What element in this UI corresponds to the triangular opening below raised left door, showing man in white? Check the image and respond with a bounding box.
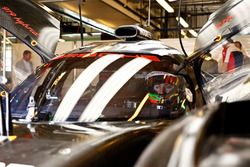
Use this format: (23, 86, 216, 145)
(0, 28, 42, 90)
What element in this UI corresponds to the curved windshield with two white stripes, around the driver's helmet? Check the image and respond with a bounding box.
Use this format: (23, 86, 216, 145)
(11, 54, 187, 122)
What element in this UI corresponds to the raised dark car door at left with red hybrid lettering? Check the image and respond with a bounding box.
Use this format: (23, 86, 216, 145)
(0, 0, 60, 61)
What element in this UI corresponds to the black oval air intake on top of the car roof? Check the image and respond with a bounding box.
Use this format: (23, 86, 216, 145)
(115, 25, 152, 40)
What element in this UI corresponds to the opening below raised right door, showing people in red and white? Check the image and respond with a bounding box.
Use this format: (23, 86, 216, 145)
(201, 35, 250, 83)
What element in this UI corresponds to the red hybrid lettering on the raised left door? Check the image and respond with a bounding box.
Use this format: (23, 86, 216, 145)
(2, 6, 39, 36)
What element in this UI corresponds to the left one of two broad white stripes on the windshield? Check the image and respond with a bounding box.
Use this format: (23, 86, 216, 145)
(53, 54, 123, 122)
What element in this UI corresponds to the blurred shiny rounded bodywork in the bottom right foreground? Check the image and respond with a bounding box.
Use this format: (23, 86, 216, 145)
(135, 101, 249, 167)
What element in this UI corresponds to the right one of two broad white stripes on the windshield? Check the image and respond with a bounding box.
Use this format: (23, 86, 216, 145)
(78, 57, 151, 122)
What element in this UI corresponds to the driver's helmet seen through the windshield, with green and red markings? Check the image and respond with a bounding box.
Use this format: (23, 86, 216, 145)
(145, 71, 186, 114)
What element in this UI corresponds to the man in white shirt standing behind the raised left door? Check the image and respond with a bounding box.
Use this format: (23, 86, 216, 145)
(15, 50, 33, 82)
